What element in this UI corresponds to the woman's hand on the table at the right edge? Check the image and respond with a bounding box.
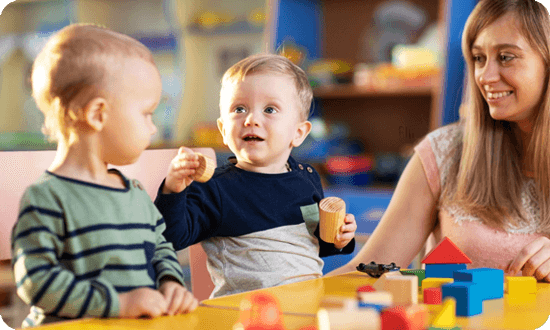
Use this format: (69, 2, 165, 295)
(506, 237, 550, 282)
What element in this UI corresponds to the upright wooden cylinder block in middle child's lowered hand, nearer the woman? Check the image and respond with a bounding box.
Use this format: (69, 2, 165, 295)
(319, 197, 346, 243)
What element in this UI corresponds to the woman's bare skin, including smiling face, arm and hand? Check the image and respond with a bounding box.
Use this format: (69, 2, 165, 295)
(328, 14, 550, 282)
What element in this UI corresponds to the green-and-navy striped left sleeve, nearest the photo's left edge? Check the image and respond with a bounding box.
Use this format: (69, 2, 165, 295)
(12, 187, 119, 318)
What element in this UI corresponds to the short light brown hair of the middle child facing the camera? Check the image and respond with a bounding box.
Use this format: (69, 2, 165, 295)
(220, 54, 313, 120)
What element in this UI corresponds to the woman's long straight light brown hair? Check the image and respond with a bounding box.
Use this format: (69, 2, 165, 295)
(442, 0, 550, 233)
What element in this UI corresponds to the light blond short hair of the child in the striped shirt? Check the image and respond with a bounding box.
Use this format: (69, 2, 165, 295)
(31, 24, 154, 141)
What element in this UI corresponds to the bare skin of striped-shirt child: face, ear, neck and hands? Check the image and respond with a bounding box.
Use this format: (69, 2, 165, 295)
(48, 59, 198, 318)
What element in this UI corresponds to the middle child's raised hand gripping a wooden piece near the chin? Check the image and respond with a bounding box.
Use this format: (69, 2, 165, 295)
(162, 147, 199, 194)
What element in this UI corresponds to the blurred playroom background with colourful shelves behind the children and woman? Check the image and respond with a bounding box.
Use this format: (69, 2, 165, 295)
(0, 0, 476, 324)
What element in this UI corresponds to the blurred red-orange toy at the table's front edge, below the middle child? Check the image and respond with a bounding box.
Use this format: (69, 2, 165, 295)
(233, 292, 286, 330)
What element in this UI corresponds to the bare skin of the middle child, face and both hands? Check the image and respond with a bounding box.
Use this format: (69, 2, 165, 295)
(162, 73, 357, 249)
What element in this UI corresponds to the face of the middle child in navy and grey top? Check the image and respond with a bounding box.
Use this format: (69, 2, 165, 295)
(218, 73, 309, 173)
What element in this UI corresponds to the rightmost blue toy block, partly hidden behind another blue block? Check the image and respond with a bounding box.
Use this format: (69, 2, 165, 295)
(453, 268, 504, 300)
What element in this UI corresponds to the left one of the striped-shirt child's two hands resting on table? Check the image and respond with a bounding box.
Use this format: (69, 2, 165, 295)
(118, 288, 168, 318)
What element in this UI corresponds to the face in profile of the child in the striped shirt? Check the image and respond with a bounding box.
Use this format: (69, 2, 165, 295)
(102, 58, 162, 165)
